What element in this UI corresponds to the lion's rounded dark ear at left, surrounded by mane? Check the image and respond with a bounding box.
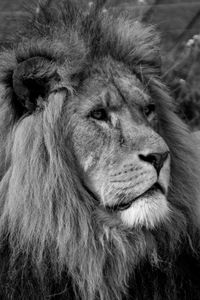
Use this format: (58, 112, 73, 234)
(13, 56, 61, 112)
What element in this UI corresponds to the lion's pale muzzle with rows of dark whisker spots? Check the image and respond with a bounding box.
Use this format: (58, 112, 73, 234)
(101, 147, 170, 206)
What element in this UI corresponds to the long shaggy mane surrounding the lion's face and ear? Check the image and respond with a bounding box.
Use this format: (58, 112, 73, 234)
(0, 1, 200, 300)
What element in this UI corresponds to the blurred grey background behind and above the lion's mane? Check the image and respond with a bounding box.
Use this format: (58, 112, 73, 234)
(0, 0, 200, 130)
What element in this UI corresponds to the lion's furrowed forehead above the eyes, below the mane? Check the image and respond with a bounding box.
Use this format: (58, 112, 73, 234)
(76, 62, 150, 110)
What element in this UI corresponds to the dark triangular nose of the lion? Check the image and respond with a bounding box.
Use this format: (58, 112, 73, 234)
(139, 151, 169, 176)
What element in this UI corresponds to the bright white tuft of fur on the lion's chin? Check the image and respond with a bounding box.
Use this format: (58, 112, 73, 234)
(120, 192, 170, 229)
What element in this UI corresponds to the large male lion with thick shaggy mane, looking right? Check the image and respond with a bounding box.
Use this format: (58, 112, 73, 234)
(0, 0, 200, 300)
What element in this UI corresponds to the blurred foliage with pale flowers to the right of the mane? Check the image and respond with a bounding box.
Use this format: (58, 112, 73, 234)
(163, 34, 200, 129)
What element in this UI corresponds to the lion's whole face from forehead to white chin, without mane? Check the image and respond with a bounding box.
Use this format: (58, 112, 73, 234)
(71, 62, 170, 228)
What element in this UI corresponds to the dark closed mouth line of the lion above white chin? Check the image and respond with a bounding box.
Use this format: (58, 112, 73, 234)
(106, 182, 165, 211)
